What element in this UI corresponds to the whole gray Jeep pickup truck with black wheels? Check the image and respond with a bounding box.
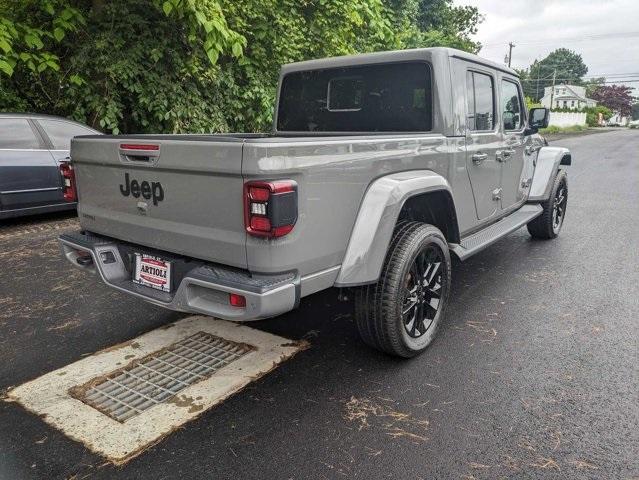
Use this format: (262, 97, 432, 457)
(60, 48, 571, 357)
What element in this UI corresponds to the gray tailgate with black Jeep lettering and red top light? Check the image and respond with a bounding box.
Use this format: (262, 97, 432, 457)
(71, 135, 246, 268)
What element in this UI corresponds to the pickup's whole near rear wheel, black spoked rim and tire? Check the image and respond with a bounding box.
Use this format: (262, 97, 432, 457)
(355, 222, 451, 358)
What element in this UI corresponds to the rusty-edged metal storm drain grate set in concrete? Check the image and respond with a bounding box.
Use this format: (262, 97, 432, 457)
(73, 332, 253, 422)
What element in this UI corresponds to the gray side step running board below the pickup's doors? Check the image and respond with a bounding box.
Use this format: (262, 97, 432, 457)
(450, 204, 543, 260)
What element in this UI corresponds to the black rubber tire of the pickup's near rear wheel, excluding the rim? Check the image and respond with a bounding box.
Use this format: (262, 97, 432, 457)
(355, 222, 451, 358)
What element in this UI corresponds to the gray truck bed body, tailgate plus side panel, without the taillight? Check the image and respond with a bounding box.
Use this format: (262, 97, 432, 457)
(71, 133, 452, 284)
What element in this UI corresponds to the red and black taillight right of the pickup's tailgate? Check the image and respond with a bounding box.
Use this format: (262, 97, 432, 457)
(244, 180, 297, 238)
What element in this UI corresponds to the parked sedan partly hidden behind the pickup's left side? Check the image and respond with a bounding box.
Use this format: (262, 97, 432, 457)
(0, 113, 99, 219)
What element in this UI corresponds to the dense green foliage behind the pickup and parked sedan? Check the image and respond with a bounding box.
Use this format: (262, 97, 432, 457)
(0, 0, 481, 133)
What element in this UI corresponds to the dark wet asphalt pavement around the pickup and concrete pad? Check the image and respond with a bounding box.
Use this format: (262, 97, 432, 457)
(0, 130, 639, 479)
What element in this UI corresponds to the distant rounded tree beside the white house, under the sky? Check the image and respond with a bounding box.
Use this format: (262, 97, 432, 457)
(523, 48, 588, 100)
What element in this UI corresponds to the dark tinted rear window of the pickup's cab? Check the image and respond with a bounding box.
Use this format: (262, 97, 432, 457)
(277, 62, 432, 132)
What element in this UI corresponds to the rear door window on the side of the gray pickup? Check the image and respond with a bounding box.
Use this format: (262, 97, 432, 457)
(466, 71, 495, 131)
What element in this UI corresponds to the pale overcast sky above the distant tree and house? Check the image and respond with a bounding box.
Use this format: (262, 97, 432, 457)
(454, 0, 639, 88)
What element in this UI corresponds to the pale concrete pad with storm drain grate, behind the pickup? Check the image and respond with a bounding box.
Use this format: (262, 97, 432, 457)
(8, 316, 305, 464)
